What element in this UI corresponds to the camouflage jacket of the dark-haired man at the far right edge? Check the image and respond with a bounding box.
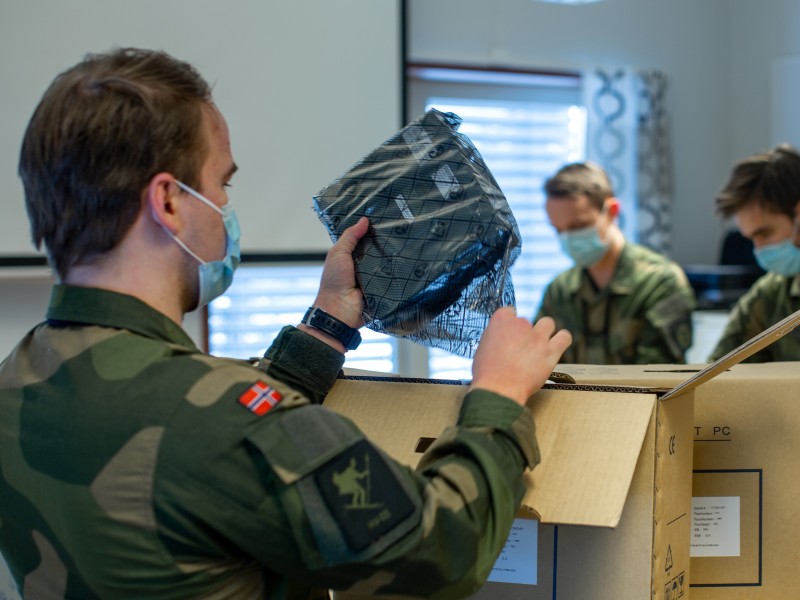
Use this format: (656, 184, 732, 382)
(709, 273, 800, 362)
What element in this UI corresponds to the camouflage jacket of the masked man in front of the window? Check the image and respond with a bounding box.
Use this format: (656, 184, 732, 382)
(536, 243, 695, 364)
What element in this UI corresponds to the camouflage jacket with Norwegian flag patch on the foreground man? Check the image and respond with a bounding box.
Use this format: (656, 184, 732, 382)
(0, 286, 538, 600)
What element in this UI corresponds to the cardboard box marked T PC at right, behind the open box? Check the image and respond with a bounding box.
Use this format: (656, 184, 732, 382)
(559, 362, 800, 600)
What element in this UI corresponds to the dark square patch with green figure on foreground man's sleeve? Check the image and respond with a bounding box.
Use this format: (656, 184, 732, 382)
(314, 440, 414, 552)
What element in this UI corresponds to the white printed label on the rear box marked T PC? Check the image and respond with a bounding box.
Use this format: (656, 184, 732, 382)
(690, 496, 741, 557)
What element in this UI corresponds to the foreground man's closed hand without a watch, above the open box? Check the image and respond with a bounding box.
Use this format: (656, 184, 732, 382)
(470, 307, 572, 404)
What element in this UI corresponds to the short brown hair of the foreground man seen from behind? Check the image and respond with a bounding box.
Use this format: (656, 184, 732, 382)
(19, 48, 211, 278)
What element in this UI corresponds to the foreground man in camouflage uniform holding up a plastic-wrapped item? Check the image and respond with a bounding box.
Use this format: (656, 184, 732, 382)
(0, 49, 570, 600)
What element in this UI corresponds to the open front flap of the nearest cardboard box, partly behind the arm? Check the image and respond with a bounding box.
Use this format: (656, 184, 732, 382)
(325, 377, 656, 527)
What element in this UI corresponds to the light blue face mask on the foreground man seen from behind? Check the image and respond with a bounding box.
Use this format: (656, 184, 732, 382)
(162, 180, 241, 308)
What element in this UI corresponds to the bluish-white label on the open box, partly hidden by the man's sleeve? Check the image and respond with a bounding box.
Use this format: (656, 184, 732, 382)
(487, 519, 539, 585)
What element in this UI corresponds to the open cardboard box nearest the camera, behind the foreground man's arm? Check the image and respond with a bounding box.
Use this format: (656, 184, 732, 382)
(325, 379, 693, 600)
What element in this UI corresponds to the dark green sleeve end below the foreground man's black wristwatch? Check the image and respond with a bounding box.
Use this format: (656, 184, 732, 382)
(258, 326, 344, 404)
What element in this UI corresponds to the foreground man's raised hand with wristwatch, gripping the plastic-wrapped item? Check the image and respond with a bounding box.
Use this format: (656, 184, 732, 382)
(314, 217, 369, 328)
